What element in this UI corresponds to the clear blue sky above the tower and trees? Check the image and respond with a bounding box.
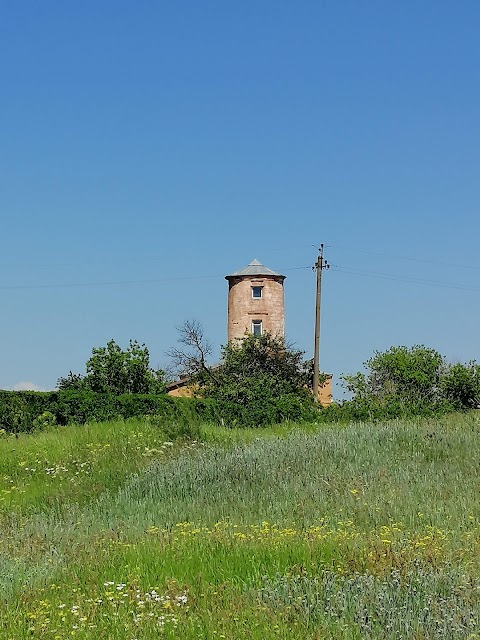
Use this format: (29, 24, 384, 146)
(0, 0, 480, 395)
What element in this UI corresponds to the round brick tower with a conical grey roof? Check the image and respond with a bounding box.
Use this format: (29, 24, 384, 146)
(225, 260, 285, 341)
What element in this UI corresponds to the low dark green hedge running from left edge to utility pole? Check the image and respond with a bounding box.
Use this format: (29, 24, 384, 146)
(0, 389, 318, 440)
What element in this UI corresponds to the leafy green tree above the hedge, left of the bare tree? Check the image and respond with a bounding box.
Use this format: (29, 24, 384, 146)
(57, 340, 165, 395)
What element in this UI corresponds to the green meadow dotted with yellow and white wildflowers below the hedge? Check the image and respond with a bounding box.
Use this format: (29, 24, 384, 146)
(0, 413, 480, 640)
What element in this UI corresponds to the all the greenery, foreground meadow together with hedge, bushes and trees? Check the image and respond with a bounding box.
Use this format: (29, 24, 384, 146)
(0, 302, 480, 640)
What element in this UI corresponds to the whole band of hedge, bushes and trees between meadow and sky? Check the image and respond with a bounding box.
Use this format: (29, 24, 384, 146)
(0, 338, 480, 433)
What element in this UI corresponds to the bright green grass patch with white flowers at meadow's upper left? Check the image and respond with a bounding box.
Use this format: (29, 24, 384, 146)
(0, 418, 197, 515)
